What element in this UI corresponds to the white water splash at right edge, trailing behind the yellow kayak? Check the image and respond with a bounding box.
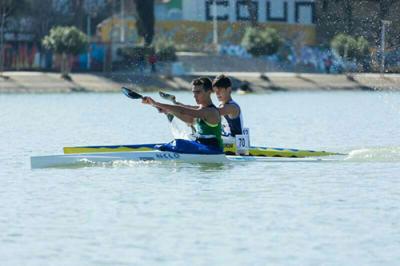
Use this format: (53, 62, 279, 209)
(345, 147, 400, 162)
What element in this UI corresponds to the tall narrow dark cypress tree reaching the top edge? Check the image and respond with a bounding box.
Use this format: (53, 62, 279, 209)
(135, 0, 155, 46)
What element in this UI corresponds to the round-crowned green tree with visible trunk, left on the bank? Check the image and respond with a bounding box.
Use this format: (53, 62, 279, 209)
(43, 27, 89, 79)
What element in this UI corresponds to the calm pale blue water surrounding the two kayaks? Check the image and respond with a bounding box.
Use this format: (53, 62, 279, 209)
(0, 92, 400, 265)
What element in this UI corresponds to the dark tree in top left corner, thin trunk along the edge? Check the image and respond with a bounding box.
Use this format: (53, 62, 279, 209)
(0, 0, 27, 74)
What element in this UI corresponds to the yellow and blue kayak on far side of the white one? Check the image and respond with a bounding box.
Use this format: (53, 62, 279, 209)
(63, 143, 342, 158)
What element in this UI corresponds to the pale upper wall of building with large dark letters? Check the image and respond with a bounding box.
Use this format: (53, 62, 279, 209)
(182, 0, 315, 25)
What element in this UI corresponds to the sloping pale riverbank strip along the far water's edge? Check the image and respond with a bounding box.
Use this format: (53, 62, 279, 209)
(0, 72, 400, 93)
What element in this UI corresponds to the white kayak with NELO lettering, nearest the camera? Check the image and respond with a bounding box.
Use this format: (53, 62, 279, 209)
(31, 150, 332, 169)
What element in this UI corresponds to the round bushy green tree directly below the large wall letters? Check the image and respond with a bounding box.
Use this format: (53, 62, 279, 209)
(242, 28, 283, 56)
